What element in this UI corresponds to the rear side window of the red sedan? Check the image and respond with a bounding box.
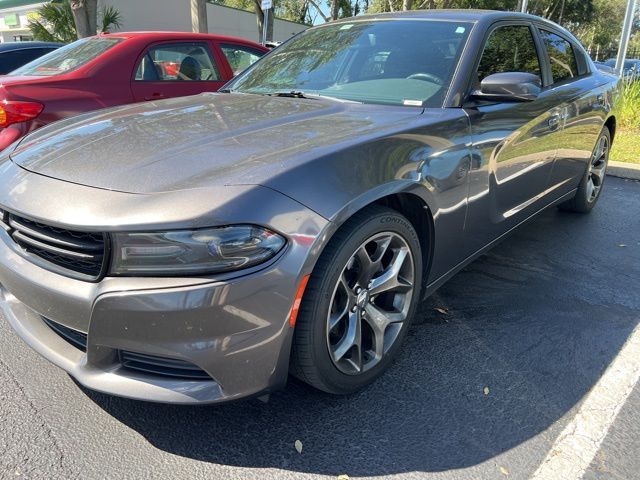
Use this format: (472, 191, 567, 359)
(135, 43, 221, 82)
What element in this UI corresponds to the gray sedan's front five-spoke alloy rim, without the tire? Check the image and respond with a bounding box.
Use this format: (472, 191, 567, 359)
(326, 232, 415, 375)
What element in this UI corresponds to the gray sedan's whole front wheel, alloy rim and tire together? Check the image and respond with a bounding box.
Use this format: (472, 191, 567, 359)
(291, 206, 422, 394)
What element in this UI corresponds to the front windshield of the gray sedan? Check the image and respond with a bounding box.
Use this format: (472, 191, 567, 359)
(227, 20, 472, 107)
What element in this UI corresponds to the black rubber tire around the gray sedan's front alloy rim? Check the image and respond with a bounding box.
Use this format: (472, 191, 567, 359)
(291, 205, 422, 394)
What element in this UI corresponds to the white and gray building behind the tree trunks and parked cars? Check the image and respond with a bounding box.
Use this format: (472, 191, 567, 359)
(0, 0, 308, 42)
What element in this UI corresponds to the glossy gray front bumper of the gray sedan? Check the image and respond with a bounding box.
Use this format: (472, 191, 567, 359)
(0, 169, 329, 404)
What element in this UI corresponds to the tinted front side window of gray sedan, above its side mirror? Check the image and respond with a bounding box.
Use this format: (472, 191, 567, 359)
(478, 25, 541, 82)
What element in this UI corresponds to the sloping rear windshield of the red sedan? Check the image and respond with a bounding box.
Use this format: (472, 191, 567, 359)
(9, 37, 123, 76)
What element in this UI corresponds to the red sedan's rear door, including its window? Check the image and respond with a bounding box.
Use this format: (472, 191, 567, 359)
(131, 41, 225, 102)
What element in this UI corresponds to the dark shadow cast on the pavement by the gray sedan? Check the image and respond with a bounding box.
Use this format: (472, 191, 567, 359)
(87, 183, 640, 476)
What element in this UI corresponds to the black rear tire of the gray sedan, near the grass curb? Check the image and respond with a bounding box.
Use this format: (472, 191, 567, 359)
(558, 127, 611, 213)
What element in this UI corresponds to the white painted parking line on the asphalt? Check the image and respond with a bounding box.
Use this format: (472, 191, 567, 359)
(531, 325, 640, 480)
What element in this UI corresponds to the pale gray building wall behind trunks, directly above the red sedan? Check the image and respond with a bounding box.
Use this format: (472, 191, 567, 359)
(99, 0, 308, 42)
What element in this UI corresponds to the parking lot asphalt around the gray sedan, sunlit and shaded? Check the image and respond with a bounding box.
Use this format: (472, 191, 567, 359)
(0, 178, 640, 479)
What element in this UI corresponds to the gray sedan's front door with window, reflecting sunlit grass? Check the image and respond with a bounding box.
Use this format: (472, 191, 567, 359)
(465, 22, 562, 251)
